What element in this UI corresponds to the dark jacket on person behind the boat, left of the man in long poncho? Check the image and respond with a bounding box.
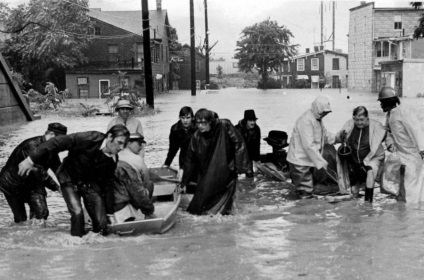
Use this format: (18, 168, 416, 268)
(165, 121, 196, 168)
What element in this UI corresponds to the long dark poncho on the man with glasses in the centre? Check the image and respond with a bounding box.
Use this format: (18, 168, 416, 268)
(182, 119, 252, 214)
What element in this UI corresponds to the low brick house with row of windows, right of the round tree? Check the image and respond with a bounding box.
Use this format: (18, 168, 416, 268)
(279, 48, 348, 88)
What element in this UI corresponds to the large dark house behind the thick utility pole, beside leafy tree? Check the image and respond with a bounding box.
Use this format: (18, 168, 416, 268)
(66, 1, 170, 98)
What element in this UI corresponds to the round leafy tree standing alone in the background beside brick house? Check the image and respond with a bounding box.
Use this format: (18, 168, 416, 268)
(235, 19, 298, 87)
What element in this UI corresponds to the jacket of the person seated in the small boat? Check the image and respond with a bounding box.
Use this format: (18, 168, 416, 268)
(114, 161, 155, 215)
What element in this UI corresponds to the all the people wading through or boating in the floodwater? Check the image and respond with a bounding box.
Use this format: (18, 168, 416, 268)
(0, 87, 424, 237)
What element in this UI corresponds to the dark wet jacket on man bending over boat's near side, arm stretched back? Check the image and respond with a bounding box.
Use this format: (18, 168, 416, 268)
(30, 131, 118, 214)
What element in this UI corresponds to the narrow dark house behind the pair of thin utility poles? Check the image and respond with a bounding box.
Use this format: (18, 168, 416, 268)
(172, 44, 206, 90)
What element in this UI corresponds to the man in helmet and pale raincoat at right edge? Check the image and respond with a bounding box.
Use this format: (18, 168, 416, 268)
(378, 86, 424, 203)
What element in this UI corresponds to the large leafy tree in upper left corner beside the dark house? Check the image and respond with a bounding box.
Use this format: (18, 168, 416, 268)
(0, 0, 93, 90)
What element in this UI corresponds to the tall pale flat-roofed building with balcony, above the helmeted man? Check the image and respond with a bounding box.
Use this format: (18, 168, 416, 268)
(349, 2, 424, 96)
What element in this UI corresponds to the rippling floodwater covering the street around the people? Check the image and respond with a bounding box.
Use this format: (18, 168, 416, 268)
(0, 89, 424, 279)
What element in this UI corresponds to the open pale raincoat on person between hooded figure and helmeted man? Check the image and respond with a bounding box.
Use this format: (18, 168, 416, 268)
(336, 120, 386, 190)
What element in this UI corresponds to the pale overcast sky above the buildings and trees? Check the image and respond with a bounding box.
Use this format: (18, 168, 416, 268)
(5, 0, 418, 59)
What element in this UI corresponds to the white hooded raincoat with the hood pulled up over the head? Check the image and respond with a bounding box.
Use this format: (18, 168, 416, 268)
(287, 96, 335, 170)
